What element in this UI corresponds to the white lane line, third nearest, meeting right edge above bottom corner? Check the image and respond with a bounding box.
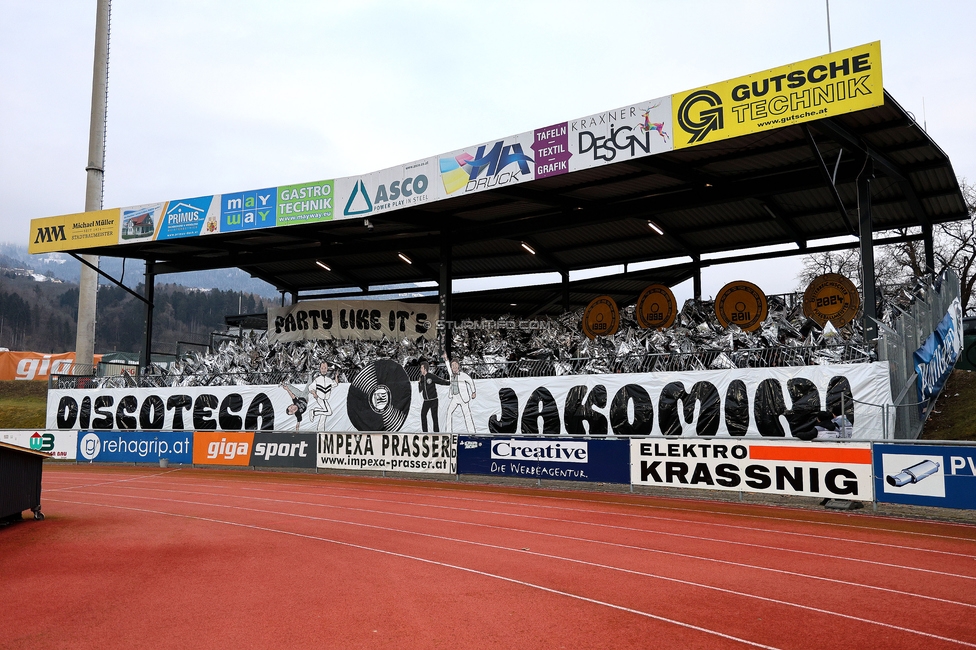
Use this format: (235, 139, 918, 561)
(74, 486, 976, 609)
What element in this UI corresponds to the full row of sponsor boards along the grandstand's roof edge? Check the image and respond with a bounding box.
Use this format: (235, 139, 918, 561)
(28, 42, 884, 254)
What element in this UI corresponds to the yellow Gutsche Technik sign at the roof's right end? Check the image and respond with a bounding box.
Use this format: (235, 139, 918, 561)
(671, 41, 884, 149)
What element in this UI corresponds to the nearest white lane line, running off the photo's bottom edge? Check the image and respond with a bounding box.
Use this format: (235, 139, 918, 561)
(43, 499, 784, 650)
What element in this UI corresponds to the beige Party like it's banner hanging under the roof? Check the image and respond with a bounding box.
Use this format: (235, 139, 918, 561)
(268, 300, 440, 345)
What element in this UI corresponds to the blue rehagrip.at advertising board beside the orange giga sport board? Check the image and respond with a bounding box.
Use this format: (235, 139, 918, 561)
(78, 431, 193, 464)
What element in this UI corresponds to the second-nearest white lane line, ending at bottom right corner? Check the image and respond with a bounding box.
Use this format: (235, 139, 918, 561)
(49, 493, 976, 648)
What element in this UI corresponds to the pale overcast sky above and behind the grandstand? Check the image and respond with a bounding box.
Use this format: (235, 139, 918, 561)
(0, 0, 976, 298)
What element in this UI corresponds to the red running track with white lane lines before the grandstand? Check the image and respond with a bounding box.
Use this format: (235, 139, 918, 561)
(0, 465, 976, 650)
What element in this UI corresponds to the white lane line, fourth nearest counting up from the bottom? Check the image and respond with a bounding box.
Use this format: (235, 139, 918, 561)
(89, 478, 976, 580)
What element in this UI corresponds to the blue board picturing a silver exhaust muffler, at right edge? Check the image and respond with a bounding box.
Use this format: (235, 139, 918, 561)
(874, 444, 976, 510)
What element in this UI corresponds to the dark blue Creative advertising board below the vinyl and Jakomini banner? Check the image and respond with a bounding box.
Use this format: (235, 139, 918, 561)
(458, 436, 630, 484)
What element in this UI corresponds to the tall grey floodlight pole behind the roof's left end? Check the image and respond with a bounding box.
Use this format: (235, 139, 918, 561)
(75, 0, 112, 374)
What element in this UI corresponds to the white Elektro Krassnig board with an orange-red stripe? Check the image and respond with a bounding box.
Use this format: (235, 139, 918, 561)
(630, 438, 872, 501)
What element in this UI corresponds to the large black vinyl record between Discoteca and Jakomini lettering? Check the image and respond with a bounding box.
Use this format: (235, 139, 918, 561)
(346, 359, 411, 431)
